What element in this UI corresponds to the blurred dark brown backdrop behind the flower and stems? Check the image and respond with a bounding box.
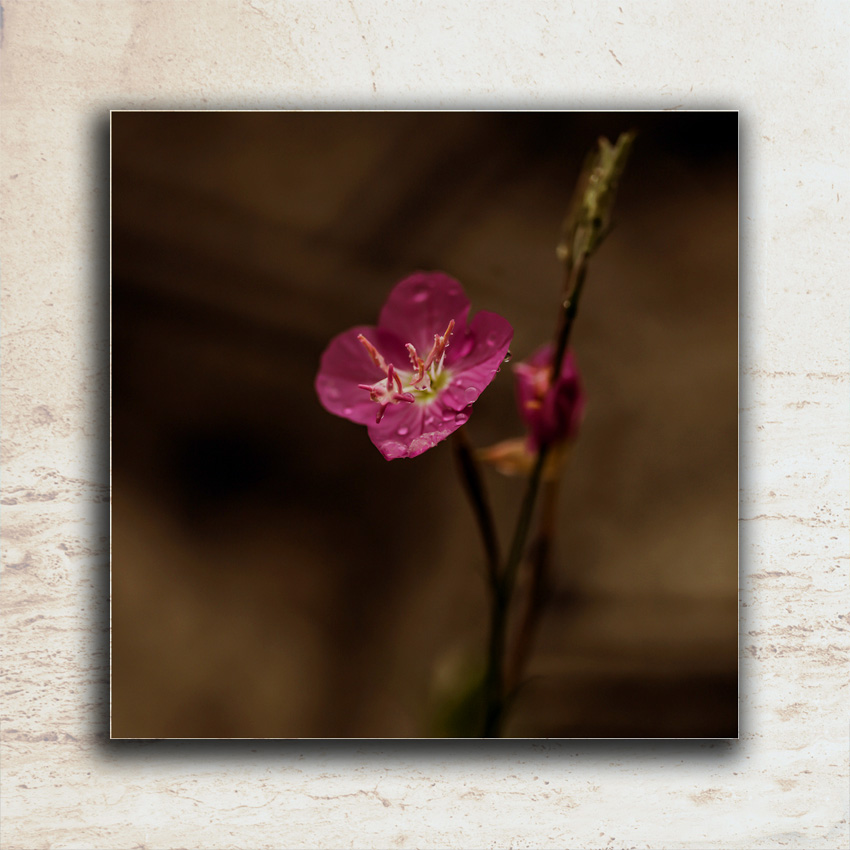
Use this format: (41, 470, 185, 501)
(112, 112, 738, 738)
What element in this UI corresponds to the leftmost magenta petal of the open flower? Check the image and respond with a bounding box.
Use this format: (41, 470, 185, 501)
(315, 325, 408, 425)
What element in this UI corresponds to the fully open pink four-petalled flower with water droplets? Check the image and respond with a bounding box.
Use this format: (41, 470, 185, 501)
(316, 272, 506, 460)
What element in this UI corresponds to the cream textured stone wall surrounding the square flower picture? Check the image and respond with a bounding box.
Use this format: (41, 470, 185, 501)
(0, 0, 850, 850)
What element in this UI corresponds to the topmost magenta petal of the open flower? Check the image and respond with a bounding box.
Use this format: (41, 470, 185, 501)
(378, 272, 469, 357)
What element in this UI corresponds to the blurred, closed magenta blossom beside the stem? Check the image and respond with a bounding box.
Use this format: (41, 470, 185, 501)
(514, 344, 585, 451)
